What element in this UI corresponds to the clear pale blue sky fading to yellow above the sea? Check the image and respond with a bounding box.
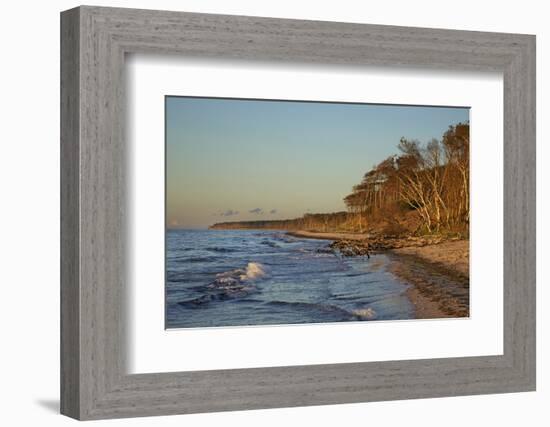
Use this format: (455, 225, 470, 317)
(165, 96, 469, 228)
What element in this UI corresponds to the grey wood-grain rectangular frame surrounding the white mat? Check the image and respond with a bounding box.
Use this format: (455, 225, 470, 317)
(61, 6, 535, 419)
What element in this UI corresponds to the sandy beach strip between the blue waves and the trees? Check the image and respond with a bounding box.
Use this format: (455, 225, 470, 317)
(288, 230, 469, 319)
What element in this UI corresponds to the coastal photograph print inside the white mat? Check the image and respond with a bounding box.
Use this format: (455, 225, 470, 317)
(165, 96, 470, 328)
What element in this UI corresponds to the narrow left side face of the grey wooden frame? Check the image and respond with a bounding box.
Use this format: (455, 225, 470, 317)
(60, 10, 80, 417)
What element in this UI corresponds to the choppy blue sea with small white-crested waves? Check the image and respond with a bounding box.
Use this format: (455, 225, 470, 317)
(165, 230, 414, 328)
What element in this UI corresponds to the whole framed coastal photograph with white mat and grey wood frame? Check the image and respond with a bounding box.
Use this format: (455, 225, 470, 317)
(61, 6, 536, 420)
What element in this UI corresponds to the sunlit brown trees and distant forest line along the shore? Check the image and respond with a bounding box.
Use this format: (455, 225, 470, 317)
(209, 123, 470, 245)
